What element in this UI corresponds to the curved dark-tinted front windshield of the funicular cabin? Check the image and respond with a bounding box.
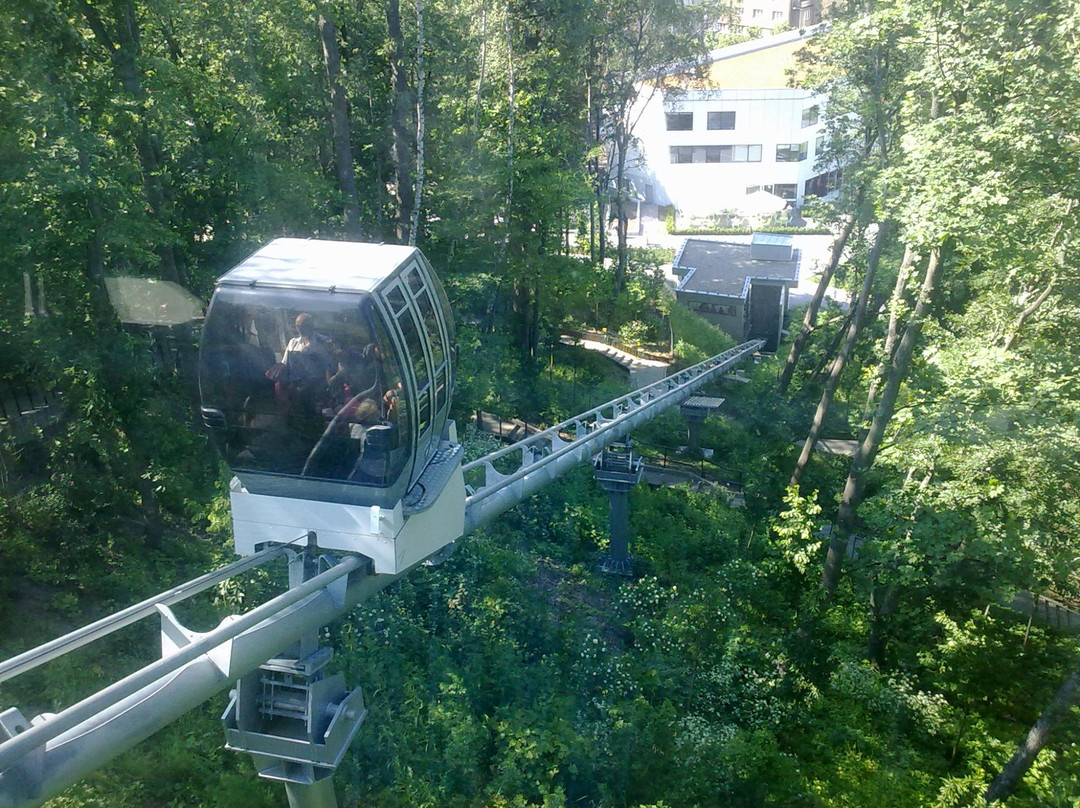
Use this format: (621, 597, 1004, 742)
(200, 287, 413, 487)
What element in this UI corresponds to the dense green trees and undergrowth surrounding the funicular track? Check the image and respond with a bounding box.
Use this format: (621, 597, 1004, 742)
(0, 0, 1080, 808)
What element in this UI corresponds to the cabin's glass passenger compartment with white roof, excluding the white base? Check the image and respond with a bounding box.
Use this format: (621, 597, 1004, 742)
(199, 239, 454, 508)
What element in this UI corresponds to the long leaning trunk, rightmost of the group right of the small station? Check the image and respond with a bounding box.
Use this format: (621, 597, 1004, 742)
(821, 245, 942, 592)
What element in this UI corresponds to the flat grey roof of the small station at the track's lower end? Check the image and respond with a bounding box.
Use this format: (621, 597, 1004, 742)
(674, 239, 801, 298)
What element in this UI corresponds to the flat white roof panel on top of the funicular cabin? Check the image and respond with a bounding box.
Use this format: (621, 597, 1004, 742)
(218, 239, 417, 292)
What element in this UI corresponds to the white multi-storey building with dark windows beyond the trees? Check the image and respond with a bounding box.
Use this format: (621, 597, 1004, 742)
(632, 29, 837, 216)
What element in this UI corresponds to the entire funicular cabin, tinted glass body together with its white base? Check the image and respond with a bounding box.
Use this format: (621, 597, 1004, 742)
(200, 239, 464, 573)
